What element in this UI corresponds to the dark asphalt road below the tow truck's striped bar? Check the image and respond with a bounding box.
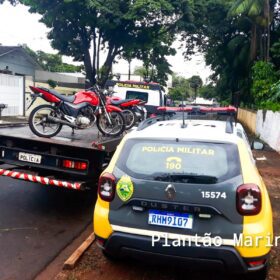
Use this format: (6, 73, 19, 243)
(0, 177, 96, 280)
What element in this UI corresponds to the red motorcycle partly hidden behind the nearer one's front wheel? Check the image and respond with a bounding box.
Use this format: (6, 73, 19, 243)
(107, 96, 147, 129)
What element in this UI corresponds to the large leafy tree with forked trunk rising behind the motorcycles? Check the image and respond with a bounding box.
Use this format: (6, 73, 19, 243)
(20, 0, 188, 85)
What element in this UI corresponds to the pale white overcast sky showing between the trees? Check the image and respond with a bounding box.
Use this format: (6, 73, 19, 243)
(0, 2, 211, 82)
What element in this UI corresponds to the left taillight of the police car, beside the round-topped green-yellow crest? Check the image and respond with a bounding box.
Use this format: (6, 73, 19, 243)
(98, 173, 116, 202)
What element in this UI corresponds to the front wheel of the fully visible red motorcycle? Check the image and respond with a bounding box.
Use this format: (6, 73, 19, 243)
(96, 112, 125, 136)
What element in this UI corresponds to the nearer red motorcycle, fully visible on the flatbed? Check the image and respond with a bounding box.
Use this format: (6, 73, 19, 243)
(29, 86, 125, 137)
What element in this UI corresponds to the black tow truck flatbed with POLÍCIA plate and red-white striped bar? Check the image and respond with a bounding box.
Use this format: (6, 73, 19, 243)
(0, 126, 122, 190)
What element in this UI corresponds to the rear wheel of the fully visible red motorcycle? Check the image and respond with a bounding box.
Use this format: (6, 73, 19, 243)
(28, 105, 62, 138)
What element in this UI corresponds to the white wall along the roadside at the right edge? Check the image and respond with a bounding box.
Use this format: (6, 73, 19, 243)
(256, 110, 280, 152)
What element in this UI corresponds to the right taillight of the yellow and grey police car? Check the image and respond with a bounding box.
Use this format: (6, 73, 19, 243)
(236, 184, 262, 216)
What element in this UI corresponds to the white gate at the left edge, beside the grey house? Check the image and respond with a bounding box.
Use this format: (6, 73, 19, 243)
(0, 74, 25, 116)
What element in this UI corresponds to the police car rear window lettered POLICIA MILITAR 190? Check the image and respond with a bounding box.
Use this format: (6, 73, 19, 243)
(117, 140, 240, 182)
